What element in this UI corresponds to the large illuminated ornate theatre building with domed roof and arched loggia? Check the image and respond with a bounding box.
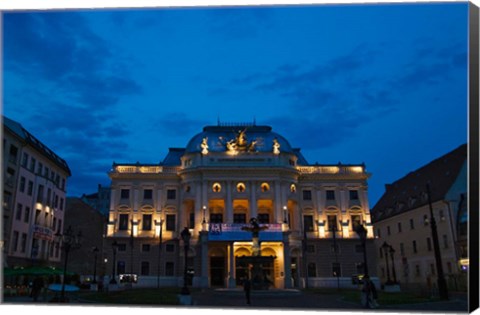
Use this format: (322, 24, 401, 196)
(106, 124, 375, 288)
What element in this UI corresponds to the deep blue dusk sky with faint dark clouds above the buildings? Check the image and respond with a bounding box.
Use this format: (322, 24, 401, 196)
(3, 2, 468, 207)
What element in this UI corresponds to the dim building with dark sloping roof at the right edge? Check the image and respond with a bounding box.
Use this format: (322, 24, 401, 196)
(372, 144, 469, 291)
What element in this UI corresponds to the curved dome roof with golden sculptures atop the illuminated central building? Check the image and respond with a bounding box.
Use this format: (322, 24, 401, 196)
(185, 125, 293, 153)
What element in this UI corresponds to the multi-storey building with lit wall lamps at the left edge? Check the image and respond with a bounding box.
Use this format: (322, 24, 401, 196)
(2, 117, 71, 267)
